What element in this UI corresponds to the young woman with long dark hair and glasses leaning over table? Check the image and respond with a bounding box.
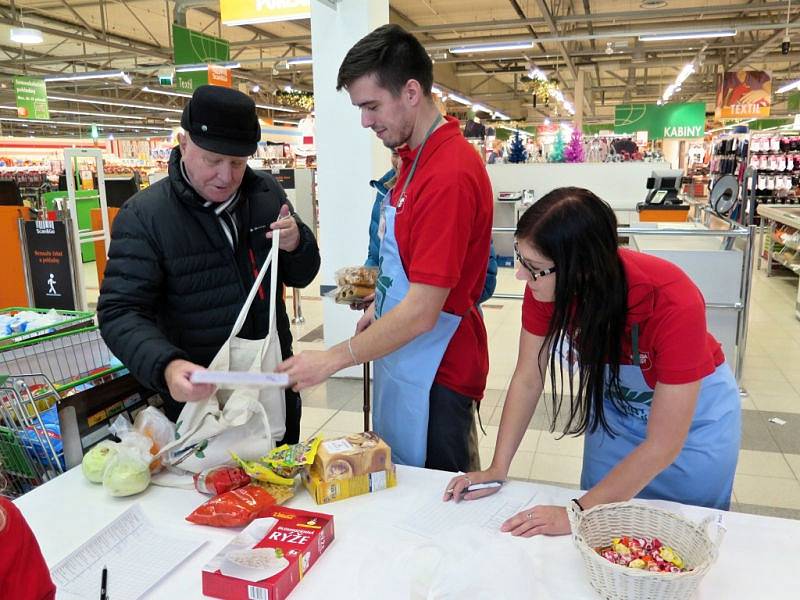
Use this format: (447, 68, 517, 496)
(444, 188, 741, 536)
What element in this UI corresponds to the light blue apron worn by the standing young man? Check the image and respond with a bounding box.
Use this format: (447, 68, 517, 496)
(372, 116, 461, 467)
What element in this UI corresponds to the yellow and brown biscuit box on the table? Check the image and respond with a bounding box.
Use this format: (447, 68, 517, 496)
(303, 431, 397, 504)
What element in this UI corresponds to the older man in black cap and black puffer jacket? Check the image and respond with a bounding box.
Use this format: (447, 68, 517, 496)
(97, 86, 320, 443)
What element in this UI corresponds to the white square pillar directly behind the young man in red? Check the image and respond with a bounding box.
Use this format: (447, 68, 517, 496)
(311, 0, 391, 377)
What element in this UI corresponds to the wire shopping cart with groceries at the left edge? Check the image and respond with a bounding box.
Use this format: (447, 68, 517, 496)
(0, 327, 127, 497)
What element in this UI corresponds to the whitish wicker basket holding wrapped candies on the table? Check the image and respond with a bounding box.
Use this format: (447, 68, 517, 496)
(567, 502, 725, 600)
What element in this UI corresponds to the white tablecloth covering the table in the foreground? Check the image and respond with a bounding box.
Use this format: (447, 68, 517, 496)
(12, 467, 800, 600)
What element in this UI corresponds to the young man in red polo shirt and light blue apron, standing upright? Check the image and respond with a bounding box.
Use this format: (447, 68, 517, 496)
(281, 25, 493, 471)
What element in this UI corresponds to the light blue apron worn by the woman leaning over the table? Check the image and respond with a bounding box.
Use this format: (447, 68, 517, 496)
(581, 325, 741, 510)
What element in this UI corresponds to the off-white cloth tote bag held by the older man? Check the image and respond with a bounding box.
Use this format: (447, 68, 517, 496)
(154, 231, 286, 485)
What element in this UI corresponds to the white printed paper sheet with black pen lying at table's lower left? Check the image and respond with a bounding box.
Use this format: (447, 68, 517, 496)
(50, 504, 205, 600)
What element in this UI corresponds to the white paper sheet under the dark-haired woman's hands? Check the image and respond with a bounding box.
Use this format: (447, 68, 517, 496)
(395, 489, 535, 538)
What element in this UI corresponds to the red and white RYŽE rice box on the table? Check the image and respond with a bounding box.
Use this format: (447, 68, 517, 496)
(203, 506, 333, 600)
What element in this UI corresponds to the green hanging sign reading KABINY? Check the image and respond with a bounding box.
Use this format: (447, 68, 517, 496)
(614, 102, 706, 140)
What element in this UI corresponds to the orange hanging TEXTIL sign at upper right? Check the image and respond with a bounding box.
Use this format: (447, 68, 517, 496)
(716, 71, 772, 119)
